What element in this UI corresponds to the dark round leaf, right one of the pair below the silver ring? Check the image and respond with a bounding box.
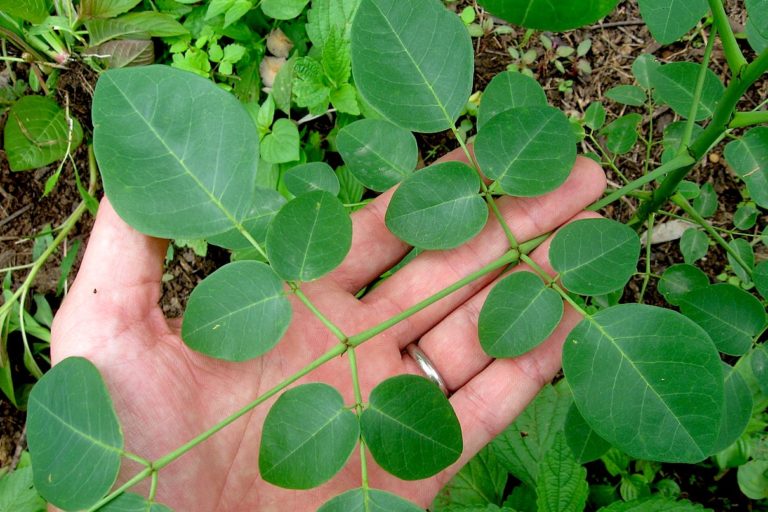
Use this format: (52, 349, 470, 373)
(360, 375, 463, 480)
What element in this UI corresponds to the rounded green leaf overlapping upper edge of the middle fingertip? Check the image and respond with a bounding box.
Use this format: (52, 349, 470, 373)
(475, 106, 576, 196)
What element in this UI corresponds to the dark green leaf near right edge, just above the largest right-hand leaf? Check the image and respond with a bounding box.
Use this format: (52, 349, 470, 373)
(679, 284, 765, 356)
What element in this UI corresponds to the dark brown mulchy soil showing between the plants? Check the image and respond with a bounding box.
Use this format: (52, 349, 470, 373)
(0, 0, 768, 504)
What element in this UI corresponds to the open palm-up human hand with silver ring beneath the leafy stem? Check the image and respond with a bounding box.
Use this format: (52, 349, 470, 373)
(51, 153, 605, 512)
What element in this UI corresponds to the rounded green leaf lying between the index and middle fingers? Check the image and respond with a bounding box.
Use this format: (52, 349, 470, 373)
(385, 162, 488, 249)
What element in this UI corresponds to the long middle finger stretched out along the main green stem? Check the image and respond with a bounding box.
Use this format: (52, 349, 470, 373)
(362, 158, 605, 348)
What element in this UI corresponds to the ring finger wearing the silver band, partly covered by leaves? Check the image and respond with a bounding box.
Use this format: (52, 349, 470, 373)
(403, 212, 600, 391)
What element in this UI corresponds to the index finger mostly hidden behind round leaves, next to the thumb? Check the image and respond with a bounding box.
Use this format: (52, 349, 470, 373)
(322, 149, 467, 293)
